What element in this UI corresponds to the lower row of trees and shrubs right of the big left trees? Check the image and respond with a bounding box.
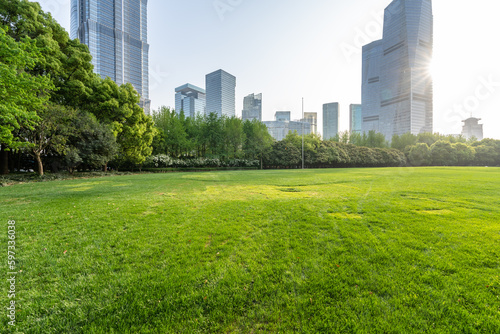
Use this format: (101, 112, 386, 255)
(144, 107, 500, 168)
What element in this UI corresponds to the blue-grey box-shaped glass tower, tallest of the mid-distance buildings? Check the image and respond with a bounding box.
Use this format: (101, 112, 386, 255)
(206, 70, 236, 117)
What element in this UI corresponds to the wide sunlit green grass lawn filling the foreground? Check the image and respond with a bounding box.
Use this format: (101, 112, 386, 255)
(0, 168, 500, 334)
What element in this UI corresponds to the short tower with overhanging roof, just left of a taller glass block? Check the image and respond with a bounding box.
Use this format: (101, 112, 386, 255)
(175, 83, 207, 118)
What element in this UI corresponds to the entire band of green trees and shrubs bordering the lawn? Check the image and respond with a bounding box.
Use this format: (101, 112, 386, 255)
(0, 0, 500, 175)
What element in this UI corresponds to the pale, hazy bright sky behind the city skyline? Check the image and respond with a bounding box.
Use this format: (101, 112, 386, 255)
(39, 0, 500, 139)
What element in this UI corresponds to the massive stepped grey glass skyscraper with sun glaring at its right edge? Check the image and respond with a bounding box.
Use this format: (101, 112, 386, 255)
(362, 0, 433, 140)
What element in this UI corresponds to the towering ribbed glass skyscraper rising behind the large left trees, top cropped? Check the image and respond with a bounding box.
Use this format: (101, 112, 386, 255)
(71, 0, 151, 114)
